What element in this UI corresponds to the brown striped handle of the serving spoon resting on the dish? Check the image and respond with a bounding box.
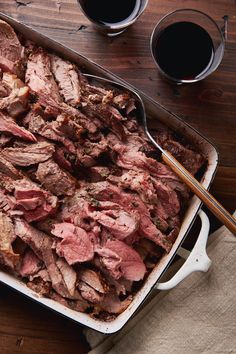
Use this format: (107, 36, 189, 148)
(162, 151, 236, 235)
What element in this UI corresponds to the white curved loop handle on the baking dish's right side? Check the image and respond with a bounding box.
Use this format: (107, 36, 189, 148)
(155, 211, 211, 290)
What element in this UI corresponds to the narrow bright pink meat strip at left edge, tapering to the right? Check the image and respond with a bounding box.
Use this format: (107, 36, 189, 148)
(0, 112, 37, 142)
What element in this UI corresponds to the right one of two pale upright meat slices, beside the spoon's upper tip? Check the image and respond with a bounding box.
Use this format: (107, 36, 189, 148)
(50, 55, 81, 107)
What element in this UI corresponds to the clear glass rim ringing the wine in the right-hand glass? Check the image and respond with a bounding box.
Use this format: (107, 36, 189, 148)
(150, 8, 225, 84)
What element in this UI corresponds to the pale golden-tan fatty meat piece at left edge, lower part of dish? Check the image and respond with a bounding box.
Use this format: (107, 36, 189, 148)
(0, 212, 19, 269)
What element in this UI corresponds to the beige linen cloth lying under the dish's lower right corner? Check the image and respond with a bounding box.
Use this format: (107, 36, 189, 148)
(85, 213, 236, 354)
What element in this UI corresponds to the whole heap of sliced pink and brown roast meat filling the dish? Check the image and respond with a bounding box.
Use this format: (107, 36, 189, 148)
(0, 21, 205, 320)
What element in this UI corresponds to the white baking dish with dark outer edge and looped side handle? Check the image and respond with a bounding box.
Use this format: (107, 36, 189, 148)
(0, 13, 218, 333)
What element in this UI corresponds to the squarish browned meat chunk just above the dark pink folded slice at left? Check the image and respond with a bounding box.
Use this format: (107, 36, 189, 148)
(36, 159, 76, 196)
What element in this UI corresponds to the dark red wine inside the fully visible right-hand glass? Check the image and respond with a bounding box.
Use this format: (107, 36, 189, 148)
(154, 21, 214, 80)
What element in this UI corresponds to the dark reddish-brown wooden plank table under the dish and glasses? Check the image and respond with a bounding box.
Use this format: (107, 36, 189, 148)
(0, 0, 236, 354)
